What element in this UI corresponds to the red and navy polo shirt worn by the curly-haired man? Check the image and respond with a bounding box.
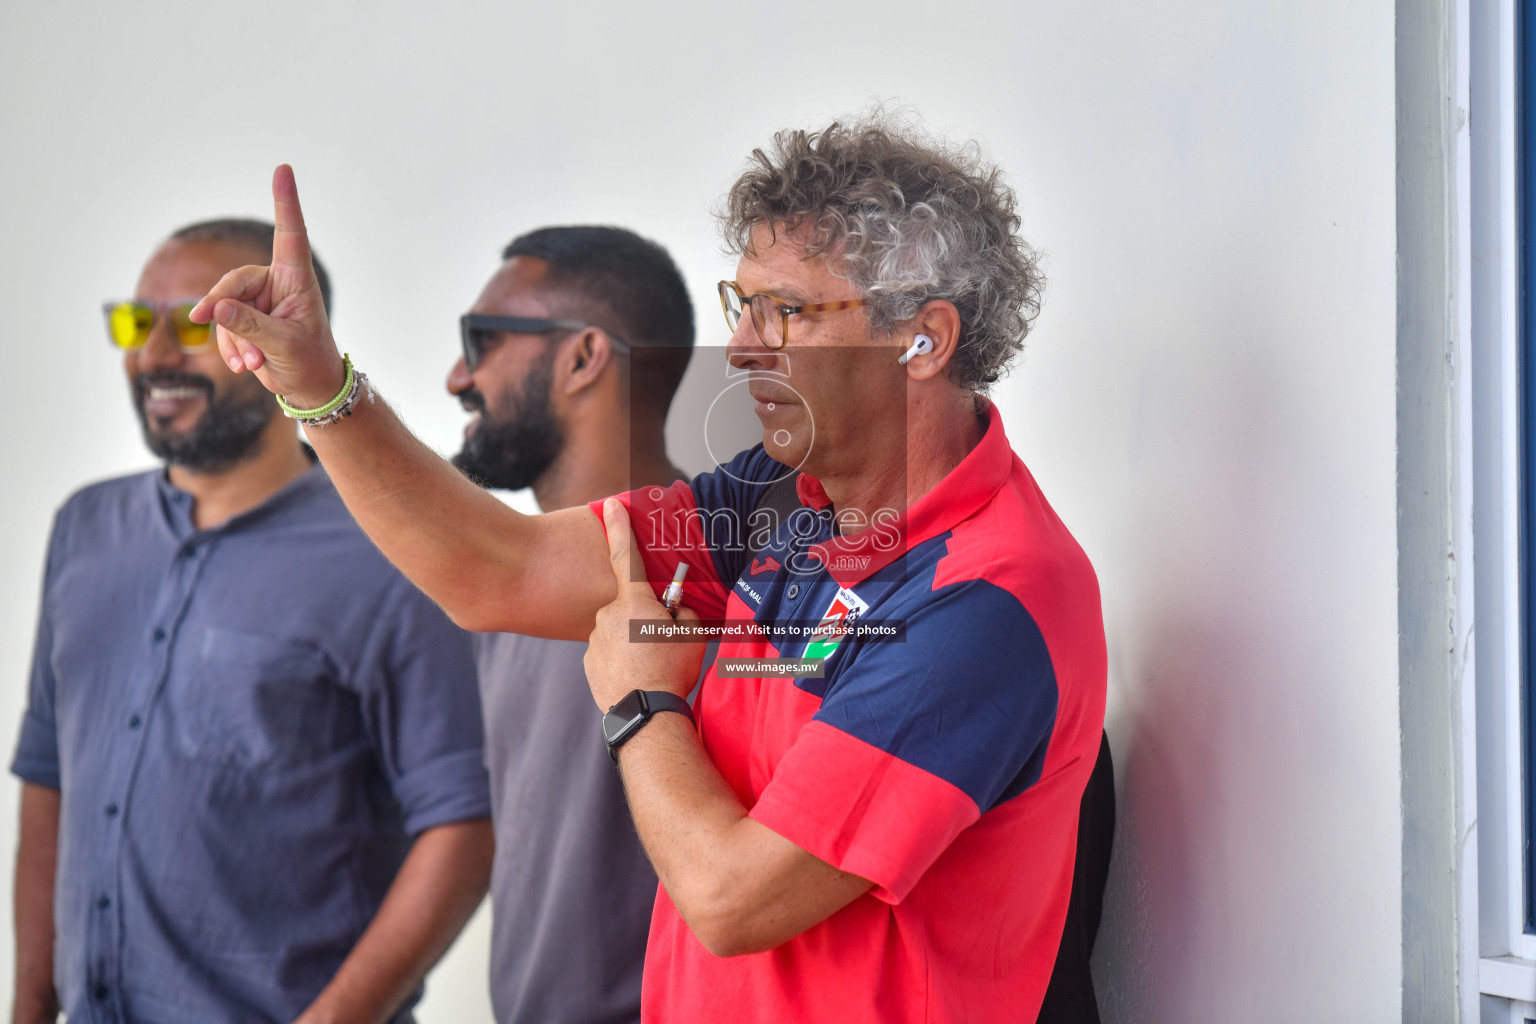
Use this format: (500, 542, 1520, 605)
(593, 407, 1106, 1024)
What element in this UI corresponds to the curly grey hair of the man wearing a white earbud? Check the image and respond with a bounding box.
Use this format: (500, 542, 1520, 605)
(719, 111, 1044, 393)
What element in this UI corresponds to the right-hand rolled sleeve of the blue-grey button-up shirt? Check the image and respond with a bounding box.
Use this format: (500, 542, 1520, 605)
(353, 577, 490, 835)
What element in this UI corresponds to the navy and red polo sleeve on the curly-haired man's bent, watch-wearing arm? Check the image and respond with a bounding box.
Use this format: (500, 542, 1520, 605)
(751, 580, 1057, 903)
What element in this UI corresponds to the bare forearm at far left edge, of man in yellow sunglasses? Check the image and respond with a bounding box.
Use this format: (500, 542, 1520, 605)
(11, 783, 60, 1024)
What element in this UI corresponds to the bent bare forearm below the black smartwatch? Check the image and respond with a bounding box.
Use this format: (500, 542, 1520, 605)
(619, 714, 869, 956)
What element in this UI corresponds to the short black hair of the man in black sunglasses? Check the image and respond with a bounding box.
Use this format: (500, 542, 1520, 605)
(501, 226, 693, 416)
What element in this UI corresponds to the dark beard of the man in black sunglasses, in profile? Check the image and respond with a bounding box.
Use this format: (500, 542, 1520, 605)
(453, 345, 565, 491)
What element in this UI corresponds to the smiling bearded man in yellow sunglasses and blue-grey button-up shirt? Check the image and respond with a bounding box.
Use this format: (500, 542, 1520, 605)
(12, 221, 492, 1024)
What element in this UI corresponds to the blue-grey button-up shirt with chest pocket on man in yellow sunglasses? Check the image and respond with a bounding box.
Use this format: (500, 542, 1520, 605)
(12, 467, 490, 1024)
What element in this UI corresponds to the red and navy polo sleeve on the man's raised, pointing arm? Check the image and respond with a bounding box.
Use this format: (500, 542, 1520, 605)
(590, 445, 788, 620)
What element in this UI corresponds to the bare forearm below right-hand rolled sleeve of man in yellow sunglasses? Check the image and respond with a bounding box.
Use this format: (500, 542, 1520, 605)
(296, 820, 493, 1024)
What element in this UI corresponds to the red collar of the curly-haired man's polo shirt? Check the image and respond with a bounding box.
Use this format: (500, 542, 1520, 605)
(796, 399, 1014, 586)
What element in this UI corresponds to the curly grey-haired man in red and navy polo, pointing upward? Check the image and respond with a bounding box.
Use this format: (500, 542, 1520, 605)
(192, 117, 1106, 1024)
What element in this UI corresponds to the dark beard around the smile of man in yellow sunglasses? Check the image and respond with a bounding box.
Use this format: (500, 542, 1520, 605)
(134, 373, 276, 473)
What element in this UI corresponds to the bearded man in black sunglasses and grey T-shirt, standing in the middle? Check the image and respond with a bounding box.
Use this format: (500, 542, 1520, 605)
(449, 227, 693, 1024)
